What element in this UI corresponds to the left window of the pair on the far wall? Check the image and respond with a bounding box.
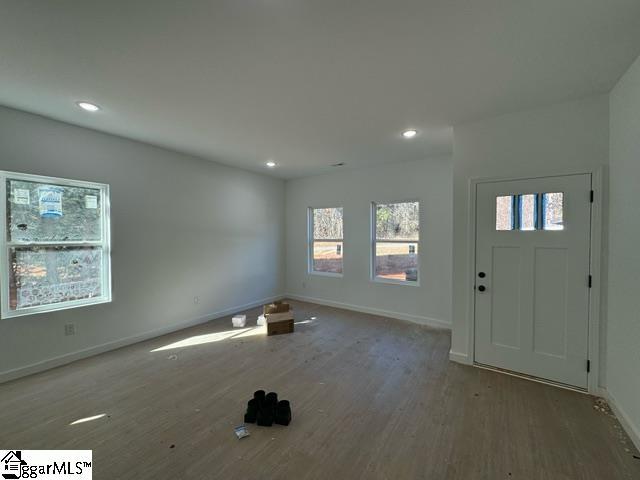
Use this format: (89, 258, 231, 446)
(309, 208, 344, 275)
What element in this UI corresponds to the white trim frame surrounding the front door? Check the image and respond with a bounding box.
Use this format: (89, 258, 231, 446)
(466, 166, 607, 395)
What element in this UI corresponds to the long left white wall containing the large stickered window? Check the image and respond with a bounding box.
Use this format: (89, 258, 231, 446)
(0, 108, 284, 379)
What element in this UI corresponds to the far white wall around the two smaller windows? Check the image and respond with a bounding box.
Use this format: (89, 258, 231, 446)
(286, 156, 452, 326)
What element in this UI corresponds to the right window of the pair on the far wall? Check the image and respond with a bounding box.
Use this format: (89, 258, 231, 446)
(372, 202, 420, 284)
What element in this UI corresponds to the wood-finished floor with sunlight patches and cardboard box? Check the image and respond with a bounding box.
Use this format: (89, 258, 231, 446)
(0, 302, 640, 480)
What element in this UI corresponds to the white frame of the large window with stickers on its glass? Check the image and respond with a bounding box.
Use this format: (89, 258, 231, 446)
(0, 170, 112, 320)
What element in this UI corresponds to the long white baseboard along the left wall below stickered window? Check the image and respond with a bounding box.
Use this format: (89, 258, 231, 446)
(0, 295, 284, 383)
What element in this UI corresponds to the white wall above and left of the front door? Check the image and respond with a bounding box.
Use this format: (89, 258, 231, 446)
(451, 95, 609, 362)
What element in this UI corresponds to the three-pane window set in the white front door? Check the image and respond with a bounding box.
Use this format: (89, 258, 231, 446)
(496, 192, 564, 232)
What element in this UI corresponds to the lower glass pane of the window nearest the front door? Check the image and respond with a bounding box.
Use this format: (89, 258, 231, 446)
(375, 242, 418, 282)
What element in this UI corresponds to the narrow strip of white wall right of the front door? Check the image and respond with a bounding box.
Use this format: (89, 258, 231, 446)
(607, 55, 640, 448)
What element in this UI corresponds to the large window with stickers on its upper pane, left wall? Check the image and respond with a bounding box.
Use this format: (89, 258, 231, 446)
(0, 172, 111, 318)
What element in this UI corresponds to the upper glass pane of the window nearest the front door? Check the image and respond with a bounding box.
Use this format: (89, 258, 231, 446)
(376, 202, 420, 241)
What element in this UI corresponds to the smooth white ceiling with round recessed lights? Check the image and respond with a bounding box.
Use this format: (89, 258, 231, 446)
(0, 0, 640, 178)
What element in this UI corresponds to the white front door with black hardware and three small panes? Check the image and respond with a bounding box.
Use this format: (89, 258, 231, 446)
(475, 174, 591, 389)
